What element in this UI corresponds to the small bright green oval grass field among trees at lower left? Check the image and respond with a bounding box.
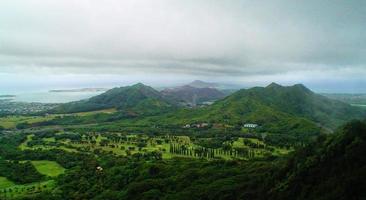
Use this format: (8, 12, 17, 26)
(31, 160, 65, 177)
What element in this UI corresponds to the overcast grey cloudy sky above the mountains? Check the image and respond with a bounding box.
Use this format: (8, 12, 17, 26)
(0, 0, 366, 93)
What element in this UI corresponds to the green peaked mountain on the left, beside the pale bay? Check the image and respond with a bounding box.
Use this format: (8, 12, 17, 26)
(52, 83, 174, 116)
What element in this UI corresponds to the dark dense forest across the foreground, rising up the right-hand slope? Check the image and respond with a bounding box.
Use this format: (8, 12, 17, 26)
(0, 121, 360, 199)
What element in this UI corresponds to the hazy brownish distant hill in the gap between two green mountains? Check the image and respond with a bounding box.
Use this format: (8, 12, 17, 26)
(161, 85, 225, 105)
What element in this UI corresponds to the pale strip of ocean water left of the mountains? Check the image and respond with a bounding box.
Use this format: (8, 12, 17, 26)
(6, 92, 103, 103)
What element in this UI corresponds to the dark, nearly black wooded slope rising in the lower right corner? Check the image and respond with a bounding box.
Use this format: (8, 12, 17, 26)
(270, 121, 366, 200)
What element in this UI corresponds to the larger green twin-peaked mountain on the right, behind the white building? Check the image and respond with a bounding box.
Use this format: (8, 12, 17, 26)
(150, 84, 363, 140)
